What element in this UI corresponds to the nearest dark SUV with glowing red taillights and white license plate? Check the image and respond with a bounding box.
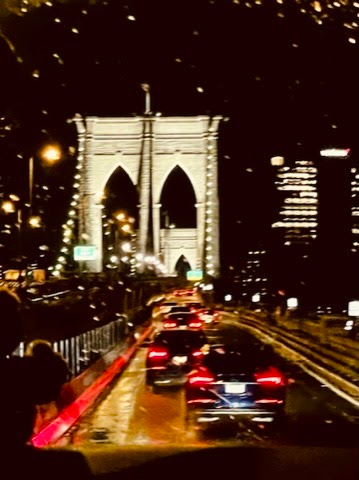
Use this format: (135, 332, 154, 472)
(185, 335, 287, 425)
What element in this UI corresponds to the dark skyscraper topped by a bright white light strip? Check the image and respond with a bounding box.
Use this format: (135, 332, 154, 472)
(315, 149, 353, 308)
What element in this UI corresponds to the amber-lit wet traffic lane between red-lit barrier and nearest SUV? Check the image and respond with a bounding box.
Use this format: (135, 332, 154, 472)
(56, 340, 270, 448)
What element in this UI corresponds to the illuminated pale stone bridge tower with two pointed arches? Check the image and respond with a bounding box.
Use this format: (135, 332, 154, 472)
(75, 115, 221, 277)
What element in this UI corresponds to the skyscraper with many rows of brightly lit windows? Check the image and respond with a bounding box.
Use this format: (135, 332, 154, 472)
(270, 157, 318, 301)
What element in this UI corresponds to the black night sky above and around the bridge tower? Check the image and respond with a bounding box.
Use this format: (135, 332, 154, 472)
(0, 0, 359, 272)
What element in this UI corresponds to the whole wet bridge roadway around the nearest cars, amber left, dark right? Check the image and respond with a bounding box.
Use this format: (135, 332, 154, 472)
(57, 315, 359, 449)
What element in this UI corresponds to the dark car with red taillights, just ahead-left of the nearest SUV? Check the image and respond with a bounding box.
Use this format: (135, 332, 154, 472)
(146, 329, 209, 386)
